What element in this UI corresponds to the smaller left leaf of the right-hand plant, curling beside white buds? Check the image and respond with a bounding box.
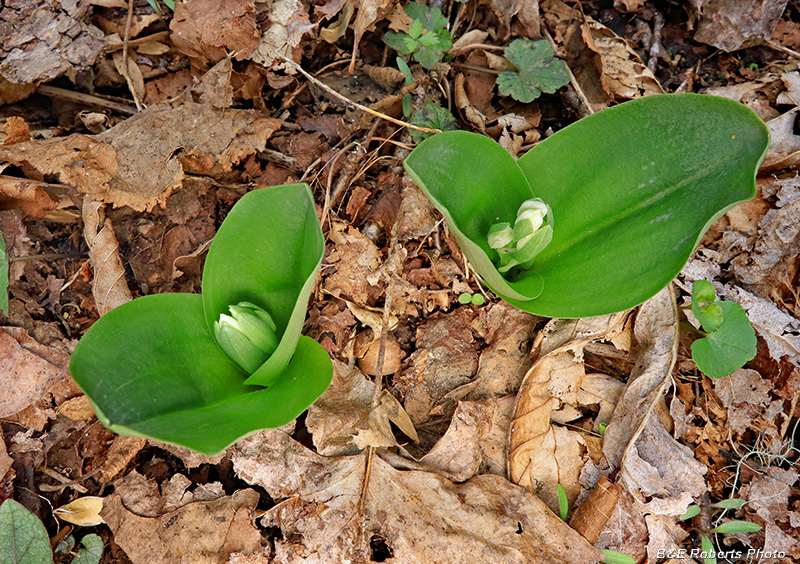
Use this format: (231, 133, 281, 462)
(403, 131, 544, 300)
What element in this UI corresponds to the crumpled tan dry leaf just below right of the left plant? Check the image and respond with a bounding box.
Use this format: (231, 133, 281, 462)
(306, 361, 419, 456)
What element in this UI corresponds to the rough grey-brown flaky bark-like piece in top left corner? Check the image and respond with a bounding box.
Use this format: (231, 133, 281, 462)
(0, 0, 105, 85)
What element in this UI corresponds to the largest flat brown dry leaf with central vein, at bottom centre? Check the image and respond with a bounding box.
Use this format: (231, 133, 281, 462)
(232, 430, 602, 564)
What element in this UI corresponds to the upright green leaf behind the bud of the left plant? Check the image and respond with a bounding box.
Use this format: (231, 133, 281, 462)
(203, 184, 325, 386)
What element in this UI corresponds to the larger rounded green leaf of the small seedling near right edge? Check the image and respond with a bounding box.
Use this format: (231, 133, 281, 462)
(692, 302, 757, 378)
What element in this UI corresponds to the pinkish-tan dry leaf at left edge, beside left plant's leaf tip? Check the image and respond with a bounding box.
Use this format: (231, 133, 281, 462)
(0, 327, 69, 418)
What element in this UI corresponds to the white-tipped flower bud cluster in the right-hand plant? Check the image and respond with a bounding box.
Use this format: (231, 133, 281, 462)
(487, 198, 553, 273)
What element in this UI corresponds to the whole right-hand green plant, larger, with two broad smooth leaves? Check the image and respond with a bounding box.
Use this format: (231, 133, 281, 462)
(404, 94, 769, 318)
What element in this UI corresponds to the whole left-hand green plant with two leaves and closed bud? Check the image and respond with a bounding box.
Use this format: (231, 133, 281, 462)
(70, 184, 333, 455)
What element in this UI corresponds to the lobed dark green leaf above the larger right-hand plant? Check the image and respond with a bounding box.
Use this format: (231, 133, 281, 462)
(497, 39, 569, 103)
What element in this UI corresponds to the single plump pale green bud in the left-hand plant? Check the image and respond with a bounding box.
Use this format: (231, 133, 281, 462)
(214, 302, 278, 374)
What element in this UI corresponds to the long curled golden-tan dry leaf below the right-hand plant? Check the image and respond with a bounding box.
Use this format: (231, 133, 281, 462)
(508, 312, 627, 511)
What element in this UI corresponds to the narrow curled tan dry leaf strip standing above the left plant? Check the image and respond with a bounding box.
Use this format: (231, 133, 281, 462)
(83, 198, 132, 315)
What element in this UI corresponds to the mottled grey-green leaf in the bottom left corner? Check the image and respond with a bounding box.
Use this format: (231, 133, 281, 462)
(0, 499, 53, 564)
